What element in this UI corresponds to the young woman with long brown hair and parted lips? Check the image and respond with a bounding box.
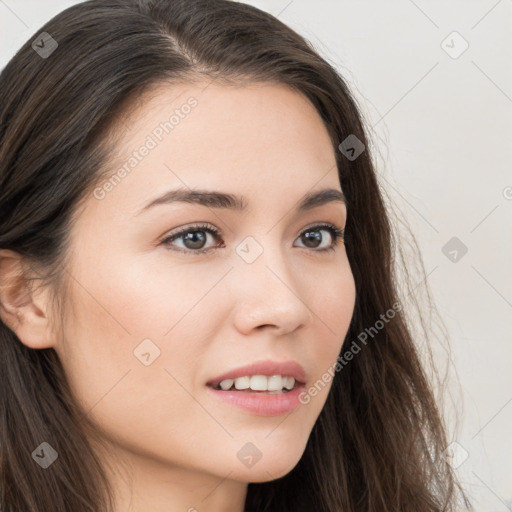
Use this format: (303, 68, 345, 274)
(0, 0, 472, 512)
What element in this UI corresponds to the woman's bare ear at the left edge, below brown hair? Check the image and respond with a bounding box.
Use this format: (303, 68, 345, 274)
(0, 249, 54, 349)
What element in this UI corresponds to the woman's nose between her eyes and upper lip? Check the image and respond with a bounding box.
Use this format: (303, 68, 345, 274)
(230, 240, 313, 336)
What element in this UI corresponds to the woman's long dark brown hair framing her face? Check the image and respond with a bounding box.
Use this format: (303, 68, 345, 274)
(0, 0, 472, 512)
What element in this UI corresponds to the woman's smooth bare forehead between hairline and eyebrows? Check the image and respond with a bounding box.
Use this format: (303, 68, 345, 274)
(89, 82, 339, 218)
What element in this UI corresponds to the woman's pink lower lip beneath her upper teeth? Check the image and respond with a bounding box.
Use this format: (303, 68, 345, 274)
(207, 384, 304, 416)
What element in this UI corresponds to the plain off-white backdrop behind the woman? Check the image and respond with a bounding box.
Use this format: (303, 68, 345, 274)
(0, 0, 512, 512)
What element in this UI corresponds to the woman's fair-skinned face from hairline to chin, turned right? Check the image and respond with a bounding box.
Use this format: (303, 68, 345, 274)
(55, 83, 355, 494)
